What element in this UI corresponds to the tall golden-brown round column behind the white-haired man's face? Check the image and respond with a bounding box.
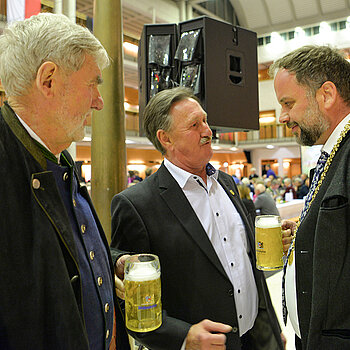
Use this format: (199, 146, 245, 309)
(91, 0, 127, 241)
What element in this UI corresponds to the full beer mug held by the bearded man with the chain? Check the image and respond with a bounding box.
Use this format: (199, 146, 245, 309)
(255, 215, 283, 271)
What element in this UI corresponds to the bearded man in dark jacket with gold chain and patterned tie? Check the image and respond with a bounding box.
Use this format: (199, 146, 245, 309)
(270, 46, 350, 350)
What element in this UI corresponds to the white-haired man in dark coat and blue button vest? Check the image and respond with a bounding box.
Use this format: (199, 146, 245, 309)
(0, 13, 129, 350)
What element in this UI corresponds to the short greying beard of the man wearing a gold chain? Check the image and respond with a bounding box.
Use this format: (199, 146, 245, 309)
(287, 100, 330, 146)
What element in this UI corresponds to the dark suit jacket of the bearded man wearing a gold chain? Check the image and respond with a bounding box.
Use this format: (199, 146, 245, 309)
(295, 134, 350, 350)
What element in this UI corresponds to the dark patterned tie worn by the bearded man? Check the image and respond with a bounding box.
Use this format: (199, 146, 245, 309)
(282, 151, 329, 325)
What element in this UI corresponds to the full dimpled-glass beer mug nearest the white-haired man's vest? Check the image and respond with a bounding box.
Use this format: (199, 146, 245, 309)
(124, 254, 162, 332)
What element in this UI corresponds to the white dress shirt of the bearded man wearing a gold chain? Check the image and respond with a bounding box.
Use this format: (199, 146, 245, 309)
(285, 114, 350, 338)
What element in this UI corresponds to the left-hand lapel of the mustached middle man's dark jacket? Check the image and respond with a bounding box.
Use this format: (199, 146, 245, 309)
(157, 164, 227, 278)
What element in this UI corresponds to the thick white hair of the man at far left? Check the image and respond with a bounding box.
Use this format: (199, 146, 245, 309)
(0, 13, 109, 96)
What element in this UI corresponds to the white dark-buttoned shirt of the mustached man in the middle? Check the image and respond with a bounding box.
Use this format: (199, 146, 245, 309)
(164, 158, 258, 348)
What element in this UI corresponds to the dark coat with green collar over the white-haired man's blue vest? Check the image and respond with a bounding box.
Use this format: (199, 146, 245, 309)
(0, 105, 129, 350)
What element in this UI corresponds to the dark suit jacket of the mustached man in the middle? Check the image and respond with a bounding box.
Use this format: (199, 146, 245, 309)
(111, 165, 282, 350)
